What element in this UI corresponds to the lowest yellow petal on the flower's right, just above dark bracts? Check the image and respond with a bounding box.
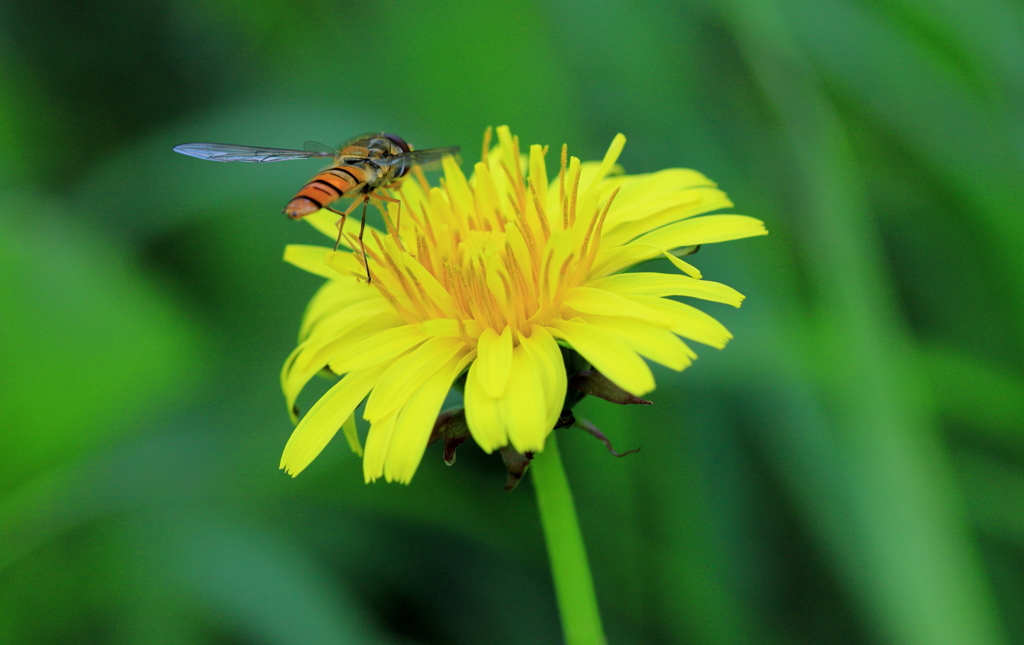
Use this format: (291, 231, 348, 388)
(547, 319, 654, 396)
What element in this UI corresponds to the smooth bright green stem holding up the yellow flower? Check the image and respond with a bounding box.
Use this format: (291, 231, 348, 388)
(530, 432, 606, 645)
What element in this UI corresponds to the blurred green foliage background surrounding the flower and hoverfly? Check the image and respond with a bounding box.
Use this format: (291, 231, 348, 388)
(0, 0, 1024, 645)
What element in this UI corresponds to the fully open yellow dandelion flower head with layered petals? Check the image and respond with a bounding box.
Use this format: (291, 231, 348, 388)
(281, 127, 767, 482)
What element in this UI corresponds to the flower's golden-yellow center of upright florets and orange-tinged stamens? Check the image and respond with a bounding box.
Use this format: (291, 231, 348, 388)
(336, 129, 621, 345)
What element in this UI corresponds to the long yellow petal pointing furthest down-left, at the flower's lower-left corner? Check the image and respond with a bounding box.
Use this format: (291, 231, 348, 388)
(281, 367, 384, 477)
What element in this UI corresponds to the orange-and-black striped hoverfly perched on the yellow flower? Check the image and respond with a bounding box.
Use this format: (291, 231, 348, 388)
(174, 132, 459, 284)
